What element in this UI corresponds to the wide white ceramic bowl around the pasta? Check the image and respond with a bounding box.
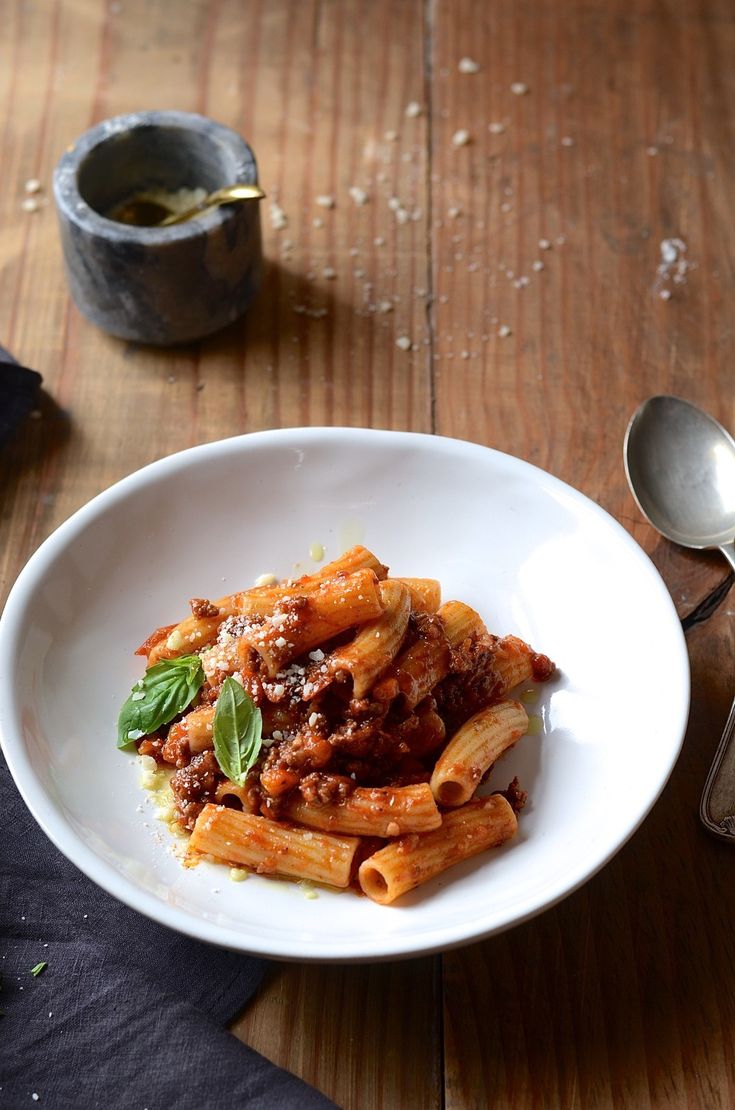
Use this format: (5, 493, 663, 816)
(0, 428, 689, 960)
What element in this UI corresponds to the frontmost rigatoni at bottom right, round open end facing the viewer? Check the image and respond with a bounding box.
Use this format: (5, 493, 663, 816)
(358, 794, 517, 906)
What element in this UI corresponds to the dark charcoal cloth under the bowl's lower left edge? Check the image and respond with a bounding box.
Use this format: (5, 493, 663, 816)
(0, 755, 334, 1110)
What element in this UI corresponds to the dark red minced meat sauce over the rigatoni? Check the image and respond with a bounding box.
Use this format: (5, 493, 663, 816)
(138, 598, 555, 829)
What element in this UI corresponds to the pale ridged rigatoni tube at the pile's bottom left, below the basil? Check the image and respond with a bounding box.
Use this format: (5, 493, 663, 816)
(189, 804, 360, 887)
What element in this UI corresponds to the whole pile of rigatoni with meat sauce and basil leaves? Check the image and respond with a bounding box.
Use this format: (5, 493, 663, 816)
(118, 547, 555, 905)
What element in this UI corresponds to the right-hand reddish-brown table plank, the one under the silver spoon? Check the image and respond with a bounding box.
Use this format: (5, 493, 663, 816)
(432, 0, 735, 1110)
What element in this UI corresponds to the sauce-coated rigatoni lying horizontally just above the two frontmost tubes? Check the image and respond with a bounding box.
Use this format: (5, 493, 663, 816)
(285, 783, 442, 837)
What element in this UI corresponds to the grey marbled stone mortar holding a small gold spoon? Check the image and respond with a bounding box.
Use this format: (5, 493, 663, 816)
(53, 111, 263, 346)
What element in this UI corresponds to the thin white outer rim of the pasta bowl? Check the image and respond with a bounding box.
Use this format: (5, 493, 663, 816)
(0, 425, 691, 963)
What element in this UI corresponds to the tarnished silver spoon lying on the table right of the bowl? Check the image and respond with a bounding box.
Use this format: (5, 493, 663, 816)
(623, 396, 735, 844)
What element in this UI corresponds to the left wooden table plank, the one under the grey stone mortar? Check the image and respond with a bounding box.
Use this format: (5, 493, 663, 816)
(0, 0, 441, 1108)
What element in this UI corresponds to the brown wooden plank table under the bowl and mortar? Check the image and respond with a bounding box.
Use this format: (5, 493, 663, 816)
(0, 0, 735, 1110)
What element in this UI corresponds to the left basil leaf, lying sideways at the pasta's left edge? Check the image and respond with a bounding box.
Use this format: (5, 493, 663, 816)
(118, 655, 204, 748)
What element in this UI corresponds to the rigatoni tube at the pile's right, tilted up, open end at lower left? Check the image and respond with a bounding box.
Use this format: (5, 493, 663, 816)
(431, 702, 528, 806)
